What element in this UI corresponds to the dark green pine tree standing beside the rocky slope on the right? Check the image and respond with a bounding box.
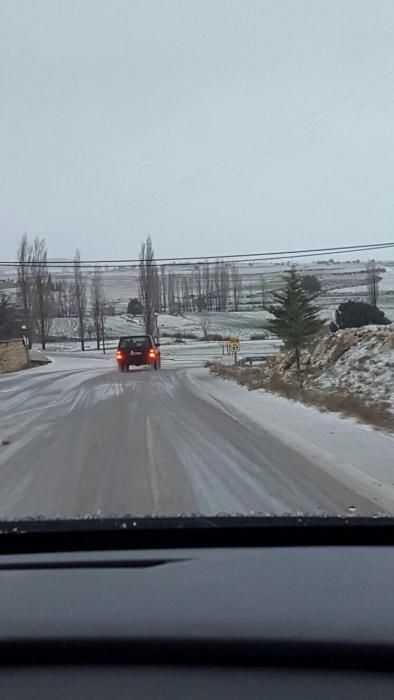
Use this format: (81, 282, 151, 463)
(268, 266, 324, 387)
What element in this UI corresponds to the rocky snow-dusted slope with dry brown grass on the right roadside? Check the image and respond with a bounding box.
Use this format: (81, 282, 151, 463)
(210, 325, 394, 432)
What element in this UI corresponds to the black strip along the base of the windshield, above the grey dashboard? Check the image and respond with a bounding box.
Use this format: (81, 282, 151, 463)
(0, 516, 394, 554)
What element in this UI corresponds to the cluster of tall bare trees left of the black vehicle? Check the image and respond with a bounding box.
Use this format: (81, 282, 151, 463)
(17, 234, 106, 350)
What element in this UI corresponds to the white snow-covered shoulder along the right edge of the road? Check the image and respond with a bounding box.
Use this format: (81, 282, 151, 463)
(187, 369, 394, 512)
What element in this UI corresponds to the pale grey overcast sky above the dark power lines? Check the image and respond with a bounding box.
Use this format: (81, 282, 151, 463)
(0, 0, 394, 259)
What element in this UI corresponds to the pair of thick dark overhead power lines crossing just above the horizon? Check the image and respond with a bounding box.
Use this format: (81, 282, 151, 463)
(0, 242, 394, 269)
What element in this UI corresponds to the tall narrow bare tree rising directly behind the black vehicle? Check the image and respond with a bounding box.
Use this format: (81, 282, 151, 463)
(139, 236, 158, 335)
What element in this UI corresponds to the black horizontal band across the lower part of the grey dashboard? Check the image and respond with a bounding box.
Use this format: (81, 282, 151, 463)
(0, 638, 394, 672)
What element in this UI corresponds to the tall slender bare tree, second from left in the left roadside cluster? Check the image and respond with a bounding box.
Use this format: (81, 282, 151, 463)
(31, 238, 52, 350)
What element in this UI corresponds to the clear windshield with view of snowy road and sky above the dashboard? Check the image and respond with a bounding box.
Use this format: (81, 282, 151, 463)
(0, 0, 394, 523)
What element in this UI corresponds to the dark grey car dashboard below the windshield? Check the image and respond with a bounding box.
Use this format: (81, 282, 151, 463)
(0, 526, 394, 700)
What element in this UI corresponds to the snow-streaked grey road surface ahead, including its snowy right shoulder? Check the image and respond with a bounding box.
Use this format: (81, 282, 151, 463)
(0, 356, 394, 518)
